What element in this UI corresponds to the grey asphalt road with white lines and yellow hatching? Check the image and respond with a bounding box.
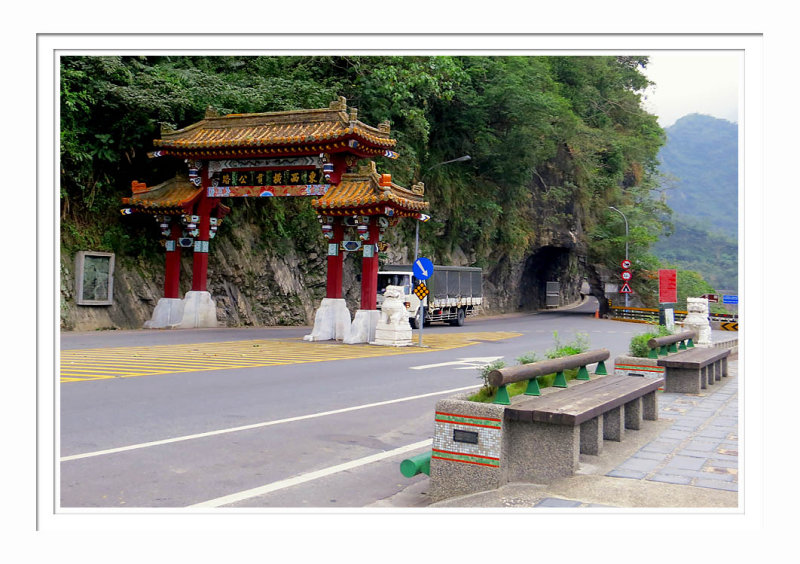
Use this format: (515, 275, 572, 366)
(57, 303, 716, 510)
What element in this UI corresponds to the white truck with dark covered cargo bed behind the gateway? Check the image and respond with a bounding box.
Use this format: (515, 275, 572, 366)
(378, 264, 483, 329)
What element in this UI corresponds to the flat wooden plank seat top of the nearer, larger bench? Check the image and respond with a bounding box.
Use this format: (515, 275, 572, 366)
(505, 376, 664, 425)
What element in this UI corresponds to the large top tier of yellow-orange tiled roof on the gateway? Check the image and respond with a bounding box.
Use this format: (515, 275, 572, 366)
(154, 97, 396, 154)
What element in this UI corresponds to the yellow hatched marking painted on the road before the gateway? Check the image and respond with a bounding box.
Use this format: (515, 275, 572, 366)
(61, 332, 522, 383)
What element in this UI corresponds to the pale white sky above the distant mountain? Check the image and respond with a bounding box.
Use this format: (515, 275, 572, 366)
(644, 51, 742, 127)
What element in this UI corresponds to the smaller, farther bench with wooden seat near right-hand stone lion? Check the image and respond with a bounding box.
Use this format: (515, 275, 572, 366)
(658, 347, 731, 394)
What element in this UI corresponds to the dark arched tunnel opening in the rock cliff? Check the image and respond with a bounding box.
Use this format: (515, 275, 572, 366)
(519, 247, 580, 311)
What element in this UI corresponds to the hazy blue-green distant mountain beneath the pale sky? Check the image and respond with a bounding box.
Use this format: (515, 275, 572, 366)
(653, 114, 739, 291)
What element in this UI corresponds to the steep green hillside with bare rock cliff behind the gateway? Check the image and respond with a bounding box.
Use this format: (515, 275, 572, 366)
(60, 56, 669, 329)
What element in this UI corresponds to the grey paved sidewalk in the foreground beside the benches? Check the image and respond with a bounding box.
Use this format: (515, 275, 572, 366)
(372, 355, 739, 508)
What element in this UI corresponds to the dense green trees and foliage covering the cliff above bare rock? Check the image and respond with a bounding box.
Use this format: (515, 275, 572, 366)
(60, 55, 720, 310)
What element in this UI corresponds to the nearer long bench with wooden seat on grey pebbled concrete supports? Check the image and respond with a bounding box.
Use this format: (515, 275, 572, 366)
(504, 376, 664, 482)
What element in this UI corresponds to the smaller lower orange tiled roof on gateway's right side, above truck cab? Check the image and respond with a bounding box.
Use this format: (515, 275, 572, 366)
(311, 161, 430, 215)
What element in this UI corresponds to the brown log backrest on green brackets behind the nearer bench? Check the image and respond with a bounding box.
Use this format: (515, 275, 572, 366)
(488, 349, 611, 405)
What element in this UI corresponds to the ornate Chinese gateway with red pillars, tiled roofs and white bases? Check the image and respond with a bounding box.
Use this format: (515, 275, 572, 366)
(122, 97, 429, 343)
